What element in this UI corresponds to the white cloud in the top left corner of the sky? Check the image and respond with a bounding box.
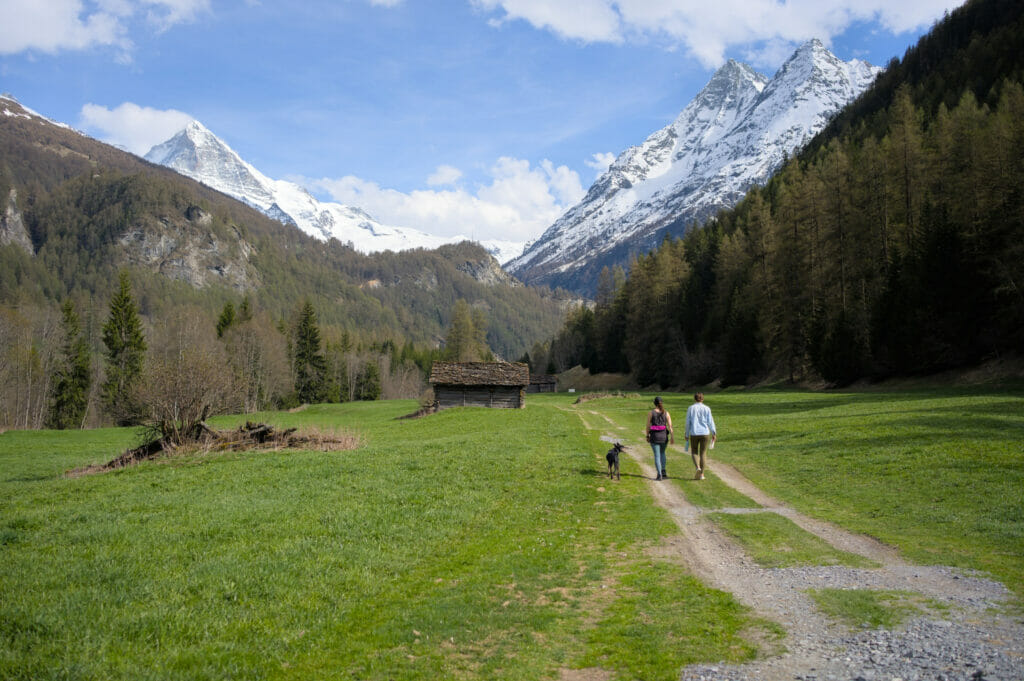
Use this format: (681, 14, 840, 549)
(0, 0, 210, 54)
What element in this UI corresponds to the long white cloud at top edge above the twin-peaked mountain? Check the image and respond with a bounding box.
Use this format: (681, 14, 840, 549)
(470, 0, 963, 67)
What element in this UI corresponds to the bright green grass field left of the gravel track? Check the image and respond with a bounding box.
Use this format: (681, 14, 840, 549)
(0, 395, 777, 679)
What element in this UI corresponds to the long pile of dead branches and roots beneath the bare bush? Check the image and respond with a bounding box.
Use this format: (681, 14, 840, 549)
(69, 421, 360, 476)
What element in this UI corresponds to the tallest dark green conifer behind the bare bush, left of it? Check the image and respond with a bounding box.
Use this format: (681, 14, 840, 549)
(101, 272, 146, 426)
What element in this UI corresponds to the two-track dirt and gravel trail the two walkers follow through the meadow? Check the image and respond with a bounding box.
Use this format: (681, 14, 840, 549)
(588, 410, 1024, 681)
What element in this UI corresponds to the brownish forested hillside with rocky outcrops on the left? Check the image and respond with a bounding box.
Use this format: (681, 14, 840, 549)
(0, 98, 568, 427)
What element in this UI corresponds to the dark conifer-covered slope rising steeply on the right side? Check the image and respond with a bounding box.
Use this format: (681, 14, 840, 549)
(551, 0, 1024, 386)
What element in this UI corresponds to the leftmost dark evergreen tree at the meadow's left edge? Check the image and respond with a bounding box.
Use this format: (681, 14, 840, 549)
(46, 299, 91, 429)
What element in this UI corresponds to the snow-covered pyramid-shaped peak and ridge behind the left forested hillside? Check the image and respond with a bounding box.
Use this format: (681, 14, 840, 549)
(145, 121, 522, 262)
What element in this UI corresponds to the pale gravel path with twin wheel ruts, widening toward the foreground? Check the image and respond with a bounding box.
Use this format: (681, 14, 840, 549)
(590, 412, 1024, 681)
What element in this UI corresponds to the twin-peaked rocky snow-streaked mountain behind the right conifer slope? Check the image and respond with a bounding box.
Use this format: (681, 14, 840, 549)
(506, 40, 882, 295)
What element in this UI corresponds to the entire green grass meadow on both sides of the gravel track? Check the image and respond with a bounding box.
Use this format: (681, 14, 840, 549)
(0, 389, 1024, 679)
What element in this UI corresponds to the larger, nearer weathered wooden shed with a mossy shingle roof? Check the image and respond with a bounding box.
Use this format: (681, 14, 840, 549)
(430, 361, 529, 410)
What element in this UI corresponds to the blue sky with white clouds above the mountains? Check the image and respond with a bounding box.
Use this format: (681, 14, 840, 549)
(0, 0, 959, 240)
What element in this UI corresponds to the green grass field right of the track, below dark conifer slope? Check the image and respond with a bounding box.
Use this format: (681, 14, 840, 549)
(586, 386, 1024, 597)
